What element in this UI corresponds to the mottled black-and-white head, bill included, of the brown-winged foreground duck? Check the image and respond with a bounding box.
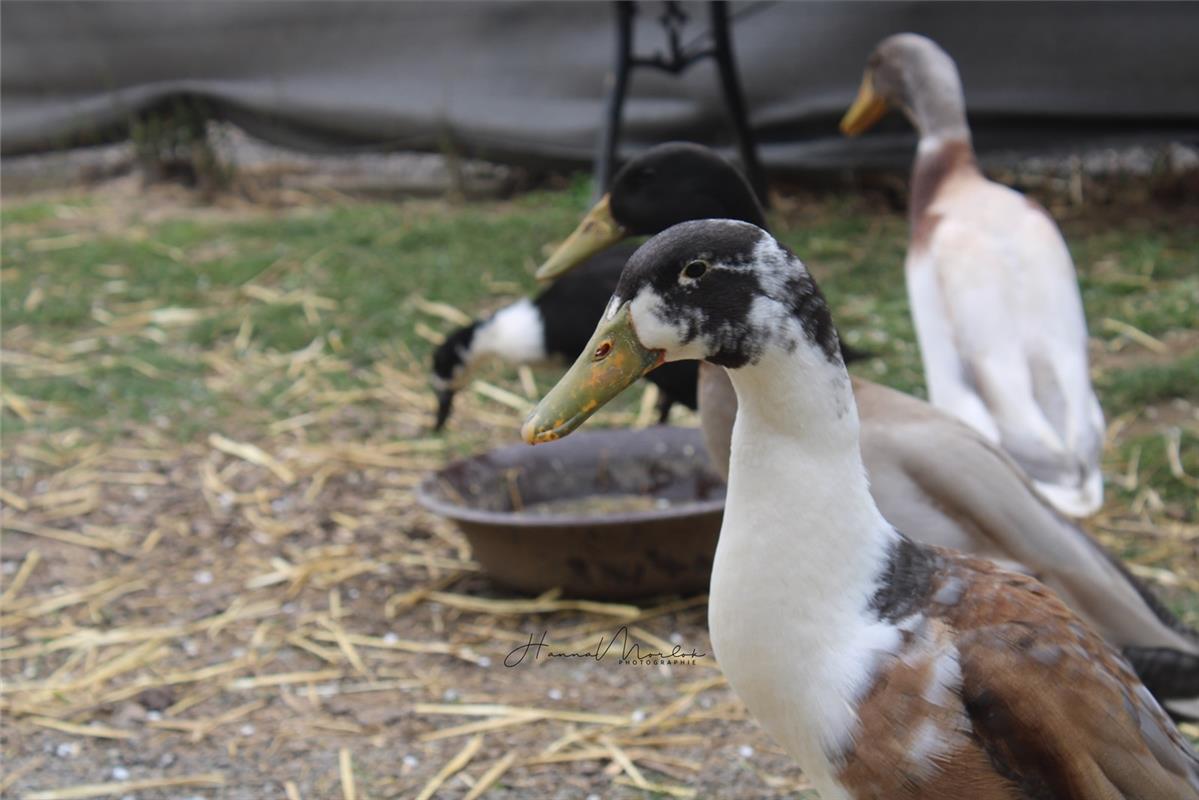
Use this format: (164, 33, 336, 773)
(522, 219, 848, 444)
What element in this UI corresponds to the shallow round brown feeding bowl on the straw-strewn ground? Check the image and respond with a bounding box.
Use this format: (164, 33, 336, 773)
(417, 426, 724, 600)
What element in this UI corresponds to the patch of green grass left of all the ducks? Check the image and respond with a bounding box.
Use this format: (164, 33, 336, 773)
(2, 179, 584, 437)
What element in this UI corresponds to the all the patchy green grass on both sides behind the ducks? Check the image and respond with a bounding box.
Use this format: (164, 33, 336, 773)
(2, 180, 1199, 513)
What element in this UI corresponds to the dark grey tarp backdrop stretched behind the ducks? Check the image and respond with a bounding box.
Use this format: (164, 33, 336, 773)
(0, 0, 1199, 168)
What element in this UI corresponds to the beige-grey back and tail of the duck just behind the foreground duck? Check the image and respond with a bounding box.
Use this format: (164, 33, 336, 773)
(854, 378, 1199, 716)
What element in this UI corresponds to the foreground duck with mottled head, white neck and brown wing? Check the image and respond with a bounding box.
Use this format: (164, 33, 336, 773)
(522, 219, 1199, 800)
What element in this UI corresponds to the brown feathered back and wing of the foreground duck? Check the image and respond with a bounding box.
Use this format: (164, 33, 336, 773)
(835, 543, 1199, 800)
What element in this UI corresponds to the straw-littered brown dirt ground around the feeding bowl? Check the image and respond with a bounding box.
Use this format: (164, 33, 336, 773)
(0, 178, 1199, 800)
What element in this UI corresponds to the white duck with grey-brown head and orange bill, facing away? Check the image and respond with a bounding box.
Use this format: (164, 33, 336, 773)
(840, 34, 1104, 517)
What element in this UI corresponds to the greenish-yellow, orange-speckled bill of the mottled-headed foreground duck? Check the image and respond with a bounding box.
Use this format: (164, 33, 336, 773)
(520, 305, 663, 445)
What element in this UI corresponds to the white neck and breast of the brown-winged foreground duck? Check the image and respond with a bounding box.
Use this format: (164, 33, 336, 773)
(709, 339, 898, 782)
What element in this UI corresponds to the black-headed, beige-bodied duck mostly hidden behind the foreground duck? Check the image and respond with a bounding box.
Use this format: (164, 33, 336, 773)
(538, 143, 1199, 718)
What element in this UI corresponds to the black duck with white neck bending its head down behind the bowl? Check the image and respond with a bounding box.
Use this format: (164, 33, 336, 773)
(429, 245, 698, 431)
